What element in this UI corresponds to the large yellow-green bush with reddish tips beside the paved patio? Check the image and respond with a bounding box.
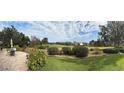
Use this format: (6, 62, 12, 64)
(28, 51, 47, 71)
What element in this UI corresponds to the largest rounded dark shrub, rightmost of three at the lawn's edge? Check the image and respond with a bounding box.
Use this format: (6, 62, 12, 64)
(74, 46, 89, 57)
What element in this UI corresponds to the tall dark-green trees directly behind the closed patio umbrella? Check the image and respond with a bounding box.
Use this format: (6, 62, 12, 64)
(0, 26, 30, 47)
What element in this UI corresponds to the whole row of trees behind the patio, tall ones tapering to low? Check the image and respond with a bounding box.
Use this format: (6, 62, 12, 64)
(0, 26, 48, 47)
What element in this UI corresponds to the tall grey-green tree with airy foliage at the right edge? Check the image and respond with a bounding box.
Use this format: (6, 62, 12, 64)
(99, 21, 124, 47)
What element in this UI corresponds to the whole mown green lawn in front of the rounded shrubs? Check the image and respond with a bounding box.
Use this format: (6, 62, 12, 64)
(43, 54, 124, 71)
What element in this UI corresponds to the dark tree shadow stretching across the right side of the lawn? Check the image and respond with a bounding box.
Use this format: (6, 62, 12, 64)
(58, 55, 124, 71)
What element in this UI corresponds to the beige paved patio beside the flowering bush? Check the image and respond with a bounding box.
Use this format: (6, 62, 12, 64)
(0, 49, 28, 71)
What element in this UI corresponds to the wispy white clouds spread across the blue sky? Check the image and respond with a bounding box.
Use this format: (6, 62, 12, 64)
(0, 21, 101, 41)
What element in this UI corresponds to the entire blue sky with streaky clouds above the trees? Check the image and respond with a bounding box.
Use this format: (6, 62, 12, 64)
(0, 21, 106, 42)
